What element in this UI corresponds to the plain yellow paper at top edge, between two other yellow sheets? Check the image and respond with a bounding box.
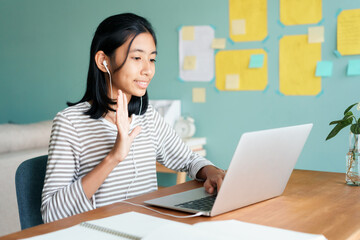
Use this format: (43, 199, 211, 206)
(280, 0, 322, 25)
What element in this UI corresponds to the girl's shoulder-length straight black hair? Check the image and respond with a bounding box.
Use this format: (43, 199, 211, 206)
(67, 13, 156, 119)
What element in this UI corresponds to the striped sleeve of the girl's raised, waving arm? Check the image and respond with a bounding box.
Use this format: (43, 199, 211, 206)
(41, 113, 94, 223)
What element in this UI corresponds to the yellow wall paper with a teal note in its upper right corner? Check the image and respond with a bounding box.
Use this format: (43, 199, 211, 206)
(215, 49, 268, 91)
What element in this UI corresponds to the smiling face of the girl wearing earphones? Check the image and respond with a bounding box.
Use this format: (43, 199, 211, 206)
(111, 33, 157, 101)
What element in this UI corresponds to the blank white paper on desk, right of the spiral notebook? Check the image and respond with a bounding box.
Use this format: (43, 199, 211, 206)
(194, 220, 326, 240)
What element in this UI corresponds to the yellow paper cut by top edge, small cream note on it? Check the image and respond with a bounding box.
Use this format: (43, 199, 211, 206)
(229, 0, 268, 42)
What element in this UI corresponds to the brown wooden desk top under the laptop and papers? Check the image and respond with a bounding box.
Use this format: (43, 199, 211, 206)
(0, 170, 360, 240)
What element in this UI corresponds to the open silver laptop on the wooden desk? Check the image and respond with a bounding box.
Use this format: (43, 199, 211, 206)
(145, 124, 313, 216)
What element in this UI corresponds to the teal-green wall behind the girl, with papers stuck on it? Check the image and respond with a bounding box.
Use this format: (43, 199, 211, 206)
(0, 0, 360, 178)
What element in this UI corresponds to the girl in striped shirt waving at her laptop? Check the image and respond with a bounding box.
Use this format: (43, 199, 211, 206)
(41, 13, 224, 223)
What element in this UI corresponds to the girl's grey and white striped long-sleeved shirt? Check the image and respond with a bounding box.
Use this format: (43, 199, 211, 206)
(41, 102, 213, 223)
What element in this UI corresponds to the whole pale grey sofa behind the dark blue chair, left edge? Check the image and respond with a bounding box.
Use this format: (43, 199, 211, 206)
(0, 121, 52, 236)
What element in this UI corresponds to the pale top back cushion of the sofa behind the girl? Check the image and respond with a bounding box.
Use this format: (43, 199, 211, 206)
(0, 121, 52, 153)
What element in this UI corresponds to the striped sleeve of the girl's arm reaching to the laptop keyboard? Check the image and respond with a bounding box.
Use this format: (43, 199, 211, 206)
(154, 110, 213, 179)
